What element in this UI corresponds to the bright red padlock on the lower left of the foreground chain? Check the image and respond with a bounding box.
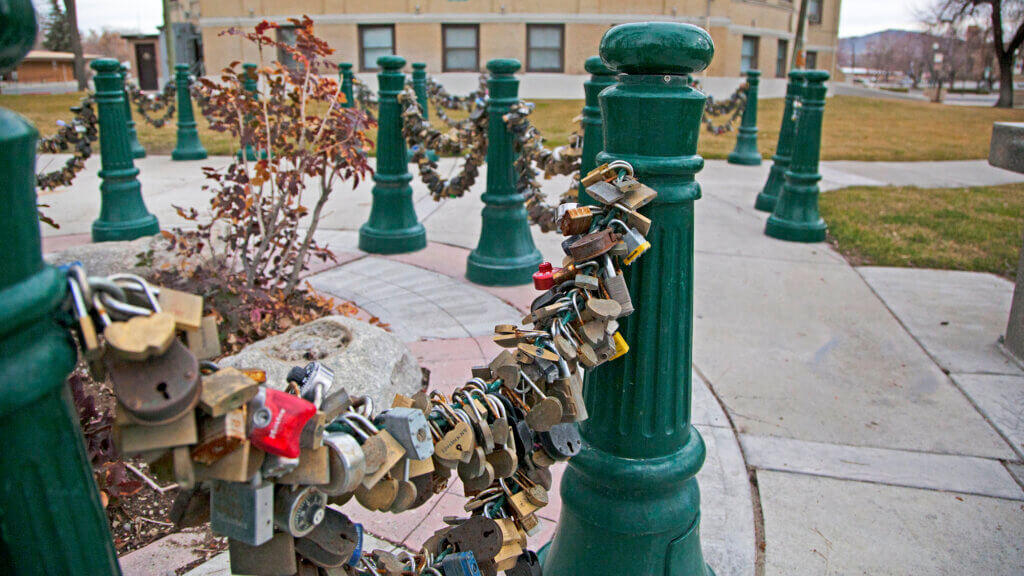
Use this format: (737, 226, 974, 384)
(249, 386, 316, 458)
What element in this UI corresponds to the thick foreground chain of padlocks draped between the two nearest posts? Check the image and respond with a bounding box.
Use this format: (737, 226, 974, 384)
(56, 157, 656, 576)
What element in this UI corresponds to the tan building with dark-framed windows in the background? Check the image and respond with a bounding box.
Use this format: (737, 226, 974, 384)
(200, 0, 841, 78)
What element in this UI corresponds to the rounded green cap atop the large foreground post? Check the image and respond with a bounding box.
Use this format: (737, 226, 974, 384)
(600, 22, 715, 76)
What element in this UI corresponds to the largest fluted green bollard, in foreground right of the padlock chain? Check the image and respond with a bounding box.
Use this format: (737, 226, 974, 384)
(543, 23, 715, 576)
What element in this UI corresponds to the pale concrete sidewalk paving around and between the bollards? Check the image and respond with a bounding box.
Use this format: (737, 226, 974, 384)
(46, 158, 1024, 576)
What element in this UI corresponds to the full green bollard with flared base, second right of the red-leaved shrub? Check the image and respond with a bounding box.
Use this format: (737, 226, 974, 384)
(466, 58, 543, 286)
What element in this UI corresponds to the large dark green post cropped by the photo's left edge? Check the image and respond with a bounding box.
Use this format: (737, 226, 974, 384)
(0, 0, 121, 576)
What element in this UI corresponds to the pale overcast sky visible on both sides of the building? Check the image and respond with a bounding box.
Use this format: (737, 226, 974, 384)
(33, 0, 928, 37)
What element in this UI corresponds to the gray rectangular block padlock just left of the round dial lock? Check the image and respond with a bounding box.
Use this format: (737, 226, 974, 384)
(210, 480, 274, 546)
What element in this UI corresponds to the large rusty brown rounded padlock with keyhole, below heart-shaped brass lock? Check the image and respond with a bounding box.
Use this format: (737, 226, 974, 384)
(104, 338, 201, 425)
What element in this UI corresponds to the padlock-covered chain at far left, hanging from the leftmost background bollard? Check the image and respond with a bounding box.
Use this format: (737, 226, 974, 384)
(36, 96, 99, 190)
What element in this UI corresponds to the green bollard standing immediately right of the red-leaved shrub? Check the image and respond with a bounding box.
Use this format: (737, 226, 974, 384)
(359, 56, 427, 254)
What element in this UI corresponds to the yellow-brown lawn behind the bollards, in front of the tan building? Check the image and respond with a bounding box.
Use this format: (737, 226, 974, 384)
(0, 93, 1024, 161)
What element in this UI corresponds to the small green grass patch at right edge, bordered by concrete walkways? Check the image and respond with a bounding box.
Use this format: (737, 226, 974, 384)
(820, 180, 1024, 279)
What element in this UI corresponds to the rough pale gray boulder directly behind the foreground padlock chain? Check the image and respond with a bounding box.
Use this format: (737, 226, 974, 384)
(218, 316, 422, 411)
